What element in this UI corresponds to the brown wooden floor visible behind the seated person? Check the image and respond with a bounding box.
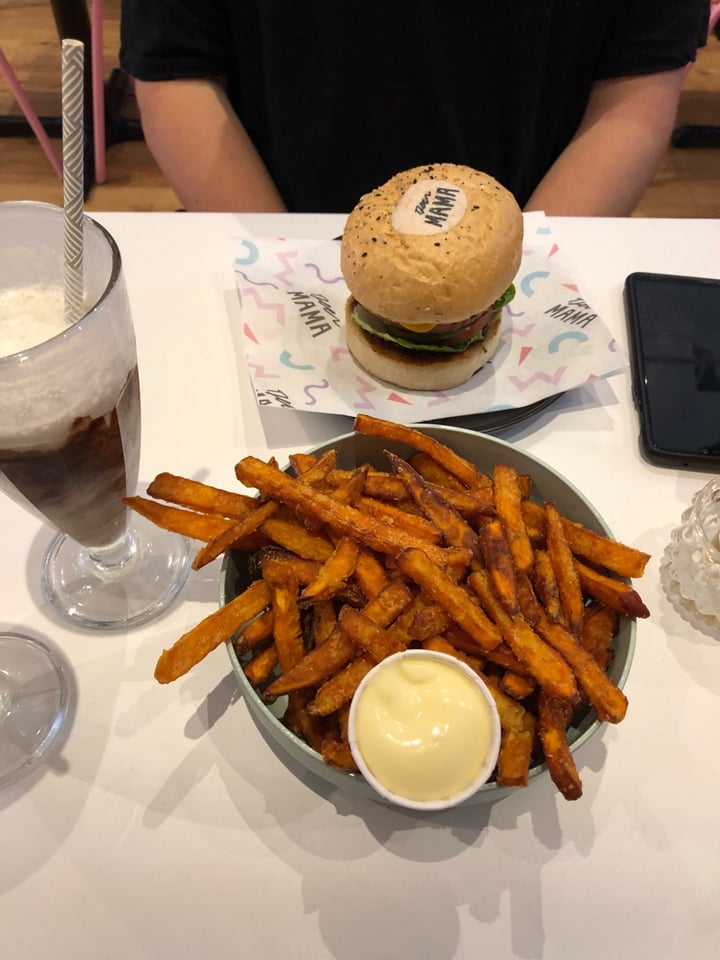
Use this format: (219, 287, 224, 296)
(0, 0, 720, 217)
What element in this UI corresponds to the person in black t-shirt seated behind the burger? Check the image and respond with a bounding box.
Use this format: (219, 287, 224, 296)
(120, 0, 708, 215)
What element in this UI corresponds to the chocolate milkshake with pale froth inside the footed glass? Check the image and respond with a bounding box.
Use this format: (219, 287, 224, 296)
(0, 284, 140, 547)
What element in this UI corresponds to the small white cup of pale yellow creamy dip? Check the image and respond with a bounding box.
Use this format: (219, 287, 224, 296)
(350, 650, 500, 809)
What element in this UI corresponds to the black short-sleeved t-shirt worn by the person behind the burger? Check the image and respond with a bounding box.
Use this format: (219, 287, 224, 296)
(120, 0, 708, 212)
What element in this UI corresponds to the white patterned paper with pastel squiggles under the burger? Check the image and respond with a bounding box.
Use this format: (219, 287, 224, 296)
(235, 213, 627, 423)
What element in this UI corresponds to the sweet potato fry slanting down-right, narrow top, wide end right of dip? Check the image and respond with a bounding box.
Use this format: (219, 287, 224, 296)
(468, 570, 577, 700)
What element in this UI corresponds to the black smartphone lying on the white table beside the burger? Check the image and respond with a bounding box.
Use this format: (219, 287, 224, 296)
(625, 273, 720, 472)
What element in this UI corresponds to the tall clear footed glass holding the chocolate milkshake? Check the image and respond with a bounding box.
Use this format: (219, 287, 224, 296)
(0, 202, 190, 632)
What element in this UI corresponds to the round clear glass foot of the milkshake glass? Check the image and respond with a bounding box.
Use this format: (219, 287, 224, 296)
(42, 515, 192, 630)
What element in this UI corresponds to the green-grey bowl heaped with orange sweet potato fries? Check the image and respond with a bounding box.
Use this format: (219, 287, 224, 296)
(128, 415, 649, 804)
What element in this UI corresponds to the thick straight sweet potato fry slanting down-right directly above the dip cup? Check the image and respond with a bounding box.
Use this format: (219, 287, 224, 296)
(397, 550, 501, 650)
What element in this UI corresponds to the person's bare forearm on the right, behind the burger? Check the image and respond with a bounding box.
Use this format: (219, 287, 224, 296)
(525, 68, 686, 217)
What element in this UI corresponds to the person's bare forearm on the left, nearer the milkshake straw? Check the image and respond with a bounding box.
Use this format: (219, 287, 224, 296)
(135, 80, 285, 212)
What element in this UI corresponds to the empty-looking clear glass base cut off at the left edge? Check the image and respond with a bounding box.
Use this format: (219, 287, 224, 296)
(0, 633, 71, 787)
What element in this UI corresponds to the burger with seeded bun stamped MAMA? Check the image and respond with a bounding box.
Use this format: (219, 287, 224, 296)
(340, 163, 523, 391)
